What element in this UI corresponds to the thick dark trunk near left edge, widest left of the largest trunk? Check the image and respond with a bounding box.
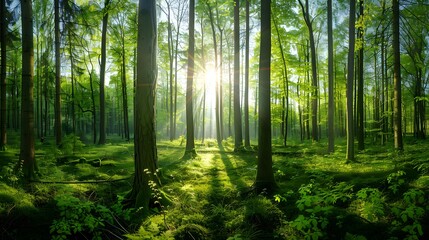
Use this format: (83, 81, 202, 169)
(19, 0, 37, 180)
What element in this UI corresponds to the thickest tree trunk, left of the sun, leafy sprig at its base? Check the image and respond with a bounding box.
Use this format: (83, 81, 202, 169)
(126, 0, 160, 210)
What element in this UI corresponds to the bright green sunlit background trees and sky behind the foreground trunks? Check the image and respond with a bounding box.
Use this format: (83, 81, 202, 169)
(0, 0, 429, 174)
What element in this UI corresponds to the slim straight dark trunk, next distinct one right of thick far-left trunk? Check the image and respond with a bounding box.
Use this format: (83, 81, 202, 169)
(54, 0, 62, 146)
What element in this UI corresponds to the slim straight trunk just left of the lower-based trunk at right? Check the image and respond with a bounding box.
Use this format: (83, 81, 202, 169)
(328, 0, 335, 153)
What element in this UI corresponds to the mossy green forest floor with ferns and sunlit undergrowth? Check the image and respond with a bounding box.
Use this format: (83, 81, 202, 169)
(0, 136, 429, 239)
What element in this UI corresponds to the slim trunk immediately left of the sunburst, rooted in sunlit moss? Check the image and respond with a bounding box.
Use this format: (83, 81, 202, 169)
(185, 0, 196, 158)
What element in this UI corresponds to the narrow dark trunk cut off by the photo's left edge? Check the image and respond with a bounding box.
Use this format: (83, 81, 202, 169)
(0, 0, 7, 151)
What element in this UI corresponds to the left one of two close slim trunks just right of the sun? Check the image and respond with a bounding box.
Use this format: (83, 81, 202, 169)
(234, 0, 243, 151)
